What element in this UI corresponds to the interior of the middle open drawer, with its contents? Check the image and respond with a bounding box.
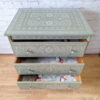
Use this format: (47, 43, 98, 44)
(16, 57, 84, 63)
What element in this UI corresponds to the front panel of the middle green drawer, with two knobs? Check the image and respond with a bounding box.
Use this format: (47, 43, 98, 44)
(15, 63, 84, 75)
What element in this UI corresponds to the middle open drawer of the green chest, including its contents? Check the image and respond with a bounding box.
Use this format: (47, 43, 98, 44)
(15, 57, 84, 75)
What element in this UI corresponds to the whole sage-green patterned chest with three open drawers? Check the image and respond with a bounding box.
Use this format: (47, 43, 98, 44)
(5, 8, 93, 89)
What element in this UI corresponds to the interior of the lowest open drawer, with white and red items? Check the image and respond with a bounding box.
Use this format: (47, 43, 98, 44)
(18, 74, 81, 82)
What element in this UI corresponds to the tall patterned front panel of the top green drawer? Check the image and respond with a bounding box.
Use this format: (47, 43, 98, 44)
(11, 42, 87, 57)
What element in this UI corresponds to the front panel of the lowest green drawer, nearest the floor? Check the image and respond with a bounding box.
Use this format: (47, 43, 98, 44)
(17, 82, 81, 90)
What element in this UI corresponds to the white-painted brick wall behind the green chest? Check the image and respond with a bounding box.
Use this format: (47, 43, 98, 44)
(0, 0, 100, 53)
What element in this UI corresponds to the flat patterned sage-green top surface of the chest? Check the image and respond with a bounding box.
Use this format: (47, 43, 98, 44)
(5, 8, 93, 36)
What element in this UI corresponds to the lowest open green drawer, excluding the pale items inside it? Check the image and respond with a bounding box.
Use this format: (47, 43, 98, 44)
(17, 75, 82, 90)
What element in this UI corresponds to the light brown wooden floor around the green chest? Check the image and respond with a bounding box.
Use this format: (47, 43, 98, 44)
(0, 55, 100, 100)
